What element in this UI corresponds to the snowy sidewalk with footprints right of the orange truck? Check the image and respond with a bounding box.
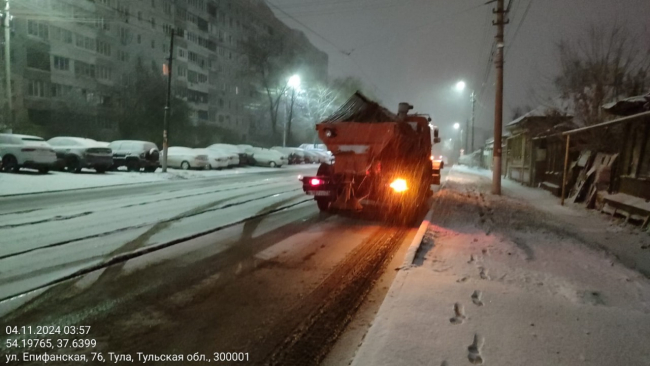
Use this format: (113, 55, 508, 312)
(352, 168, 650, 366)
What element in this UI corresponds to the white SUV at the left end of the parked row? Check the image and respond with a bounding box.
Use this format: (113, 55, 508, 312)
(0, 133, 56, 174)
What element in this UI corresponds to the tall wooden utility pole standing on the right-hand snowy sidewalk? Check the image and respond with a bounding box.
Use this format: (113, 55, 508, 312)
(492, 0, 508, 195)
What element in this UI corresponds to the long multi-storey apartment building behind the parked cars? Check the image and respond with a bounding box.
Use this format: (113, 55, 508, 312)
(0, 0, 328, 139)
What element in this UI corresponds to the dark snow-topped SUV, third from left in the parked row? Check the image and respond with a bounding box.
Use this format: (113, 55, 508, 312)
(108, 140, 160, 172)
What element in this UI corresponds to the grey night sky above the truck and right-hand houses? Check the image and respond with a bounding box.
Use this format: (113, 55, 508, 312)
(271, 0, 650, 145)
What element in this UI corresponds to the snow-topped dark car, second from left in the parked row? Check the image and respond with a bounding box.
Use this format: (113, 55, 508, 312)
(47, 137, 113, 173)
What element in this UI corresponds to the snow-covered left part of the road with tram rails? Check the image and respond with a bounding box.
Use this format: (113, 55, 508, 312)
(0, 168, 311, 299)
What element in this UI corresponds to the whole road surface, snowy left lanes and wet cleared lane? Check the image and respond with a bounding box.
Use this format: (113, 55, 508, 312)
(0, 168, 446, 365)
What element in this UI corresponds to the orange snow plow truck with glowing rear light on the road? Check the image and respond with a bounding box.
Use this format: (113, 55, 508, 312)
(302, 92, 441, 219)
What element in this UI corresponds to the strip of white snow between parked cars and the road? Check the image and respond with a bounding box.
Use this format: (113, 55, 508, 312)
(0, 165, 309, 196)
